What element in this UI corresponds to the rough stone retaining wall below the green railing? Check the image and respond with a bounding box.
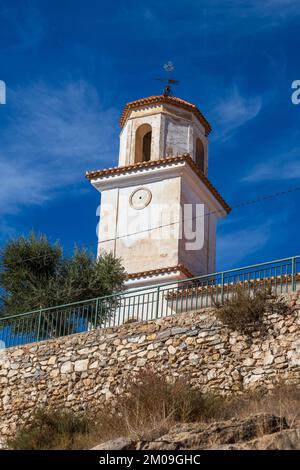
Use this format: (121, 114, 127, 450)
(0, 293, 300, 438)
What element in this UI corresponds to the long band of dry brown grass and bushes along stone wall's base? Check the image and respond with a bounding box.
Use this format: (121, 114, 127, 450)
(8, 371, 300, 449)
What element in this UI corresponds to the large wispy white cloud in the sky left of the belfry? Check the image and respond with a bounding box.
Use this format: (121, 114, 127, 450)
(0, 81, 117, 217)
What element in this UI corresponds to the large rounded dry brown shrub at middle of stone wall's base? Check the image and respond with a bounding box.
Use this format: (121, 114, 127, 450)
(113, 370, 221, 438)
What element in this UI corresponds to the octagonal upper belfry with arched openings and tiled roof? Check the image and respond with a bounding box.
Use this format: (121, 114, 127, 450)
(119, 95, 211, 175)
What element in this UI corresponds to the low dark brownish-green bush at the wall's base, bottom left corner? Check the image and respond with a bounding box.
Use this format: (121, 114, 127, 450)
(7, 409, 92, 450)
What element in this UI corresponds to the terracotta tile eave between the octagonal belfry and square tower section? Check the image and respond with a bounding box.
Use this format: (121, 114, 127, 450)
(86, 154, 231, 213)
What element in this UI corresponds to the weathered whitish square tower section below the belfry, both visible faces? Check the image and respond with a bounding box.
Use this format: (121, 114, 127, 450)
(95, 162, 226, 282)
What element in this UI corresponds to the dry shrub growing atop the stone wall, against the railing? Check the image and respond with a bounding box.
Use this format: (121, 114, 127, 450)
(215, 286, 270, 333)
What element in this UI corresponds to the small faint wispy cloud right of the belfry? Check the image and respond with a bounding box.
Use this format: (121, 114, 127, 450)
(214, 86, 262, 140)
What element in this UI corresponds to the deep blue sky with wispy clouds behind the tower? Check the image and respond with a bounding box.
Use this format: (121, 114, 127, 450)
(0, 0, 300, 269)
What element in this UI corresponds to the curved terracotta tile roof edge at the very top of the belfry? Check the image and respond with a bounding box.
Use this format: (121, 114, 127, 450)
(120, 95, 211, 135)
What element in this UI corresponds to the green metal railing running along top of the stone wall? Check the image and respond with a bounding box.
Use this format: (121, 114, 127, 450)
(0, 256, 300, 347)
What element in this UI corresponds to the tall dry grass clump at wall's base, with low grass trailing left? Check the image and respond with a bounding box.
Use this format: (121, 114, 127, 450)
(83, 370, 223, 446)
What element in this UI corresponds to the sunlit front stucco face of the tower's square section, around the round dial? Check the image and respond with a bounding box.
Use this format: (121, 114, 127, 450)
(98, 176, 181, 273)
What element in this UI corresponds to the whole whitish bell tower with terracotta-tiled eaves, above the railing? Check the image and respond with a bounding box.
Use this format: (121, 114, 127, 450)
(86, 94, 230, 286)
